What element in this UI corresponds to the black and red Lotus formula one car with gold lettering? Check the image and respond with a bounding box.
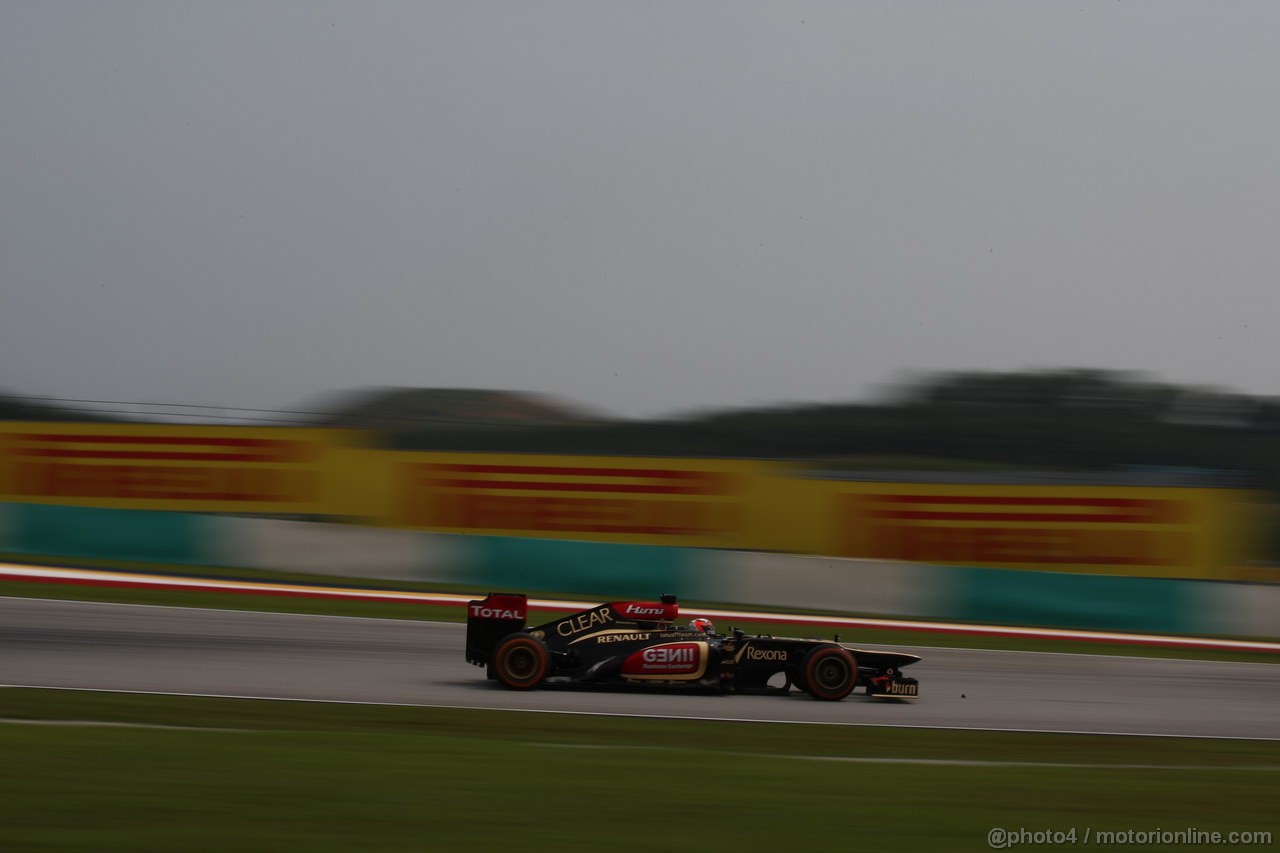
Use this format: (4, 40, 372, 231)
(466, 593, 920, 701)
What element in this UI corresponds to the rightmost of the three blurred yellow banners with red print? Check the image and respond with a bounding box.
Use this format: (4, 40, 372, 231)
(826, 483, 1244, 578)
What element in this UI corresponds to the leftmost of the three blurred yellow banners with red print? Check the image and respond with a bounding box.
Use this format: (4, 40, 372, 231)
(0, 421, 337, 515)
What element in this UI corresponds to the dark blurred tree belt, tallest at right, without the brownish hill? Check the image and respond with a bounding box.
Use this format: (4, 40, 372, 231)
(381, 370, 1280, 492)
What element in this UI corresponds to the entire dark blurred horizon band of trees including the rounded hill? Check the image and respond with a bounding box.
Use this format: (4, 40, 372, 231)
(0, 369, 1280, 560)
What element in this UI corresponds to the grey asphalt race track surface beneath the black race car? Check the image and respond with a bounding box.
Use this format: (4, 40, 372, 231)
(0, 598, 1280, 739)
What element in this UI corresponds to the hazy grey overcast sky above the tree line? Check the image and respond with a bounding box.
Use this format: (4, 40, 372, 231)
(0, 0, 1280, 416)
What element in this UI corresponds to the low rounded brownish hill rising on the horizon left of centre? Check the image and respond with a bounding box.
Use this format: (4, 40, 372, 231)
(308, 388, 602, 430)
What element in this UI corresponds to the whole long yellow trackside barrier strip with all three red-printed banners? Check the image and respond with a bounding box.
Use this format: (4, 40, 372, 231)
(0, 421, 1262, 579)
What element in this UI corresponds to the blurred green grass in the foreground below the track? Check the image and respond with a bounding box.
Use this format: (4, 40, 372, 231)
(0, 689, 1280, 852)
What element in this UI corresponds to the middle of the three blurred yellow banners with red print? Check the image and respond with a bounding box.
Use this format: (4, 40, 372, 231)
(389, 453, 769, 547)
